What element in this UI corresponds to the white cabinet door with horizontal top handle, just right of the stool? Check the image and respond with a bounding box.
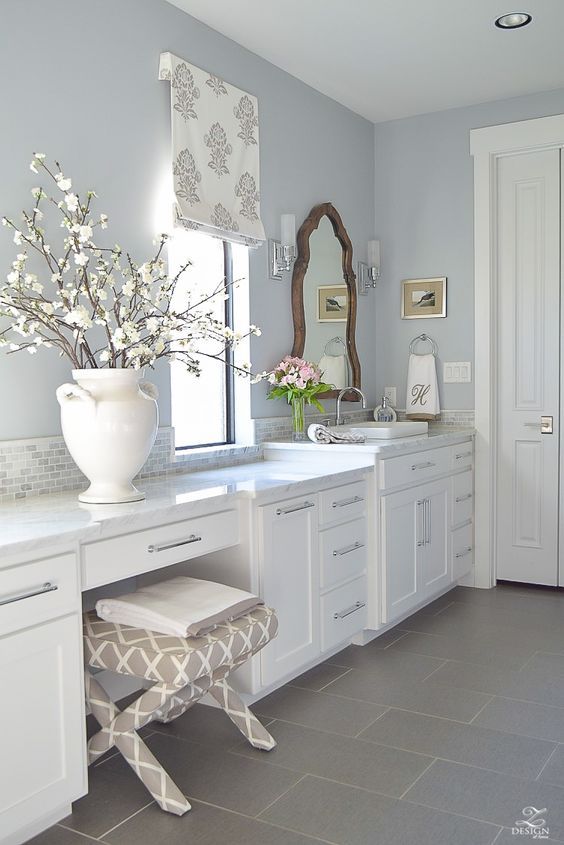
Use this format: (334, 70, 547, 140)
(260, 496, 320, 686)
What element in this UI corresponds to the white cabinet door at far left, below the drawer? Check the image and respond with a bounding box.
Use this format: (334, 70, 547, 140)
(0, 614, 86, 842)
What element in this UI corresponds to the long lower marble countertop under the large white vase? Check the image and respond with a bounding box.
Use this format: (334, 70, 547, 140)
(0, 460, 368, 567)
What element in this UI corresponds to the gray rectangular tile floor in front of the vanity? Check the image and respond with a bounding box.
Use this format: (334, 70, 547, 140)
(28, 586, 564, 845)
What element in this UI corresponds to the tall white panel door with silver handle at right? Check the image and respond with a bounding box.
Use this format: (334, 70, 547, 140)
(498, 150, 560, 585)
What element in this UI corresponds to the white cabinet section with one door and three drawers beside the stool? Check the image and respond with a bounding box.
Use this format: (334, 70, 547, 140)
(253, 479, 368, 692)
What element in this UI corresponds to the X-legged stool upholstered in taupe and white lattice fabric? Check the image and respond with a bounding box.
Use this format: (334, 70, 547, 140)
(84, 607, 278, 816)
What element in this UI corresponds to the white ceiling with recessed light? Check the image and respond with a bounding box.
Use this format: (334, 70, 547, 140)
(165, 0, 564, 122)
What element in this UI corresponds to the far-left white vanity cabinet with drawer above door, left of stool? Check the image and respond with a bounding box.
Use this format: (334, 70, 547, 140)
(0, 553, 87, 845)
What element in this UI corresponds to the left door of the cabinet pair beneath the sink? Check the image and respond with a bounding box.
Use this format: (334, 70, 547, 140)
(382, 487, 423, 622)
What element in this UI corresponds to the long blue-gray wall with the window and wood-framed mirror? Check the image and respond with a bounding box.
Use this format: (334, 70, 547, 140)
(0, 0, 376, 440)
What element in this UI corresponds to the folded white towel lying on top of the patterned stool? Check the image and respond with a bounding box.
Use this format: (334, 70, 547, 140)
(96, 575, 263, 637)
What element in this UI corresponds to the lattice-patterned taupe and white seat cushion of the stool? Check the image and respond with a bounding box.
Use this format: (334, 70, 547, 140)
(84, 607, 278, 686)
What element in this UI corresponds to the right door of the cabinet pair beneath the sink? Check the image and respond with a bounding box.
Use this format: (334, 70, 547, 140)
(419, 479, 452, 599)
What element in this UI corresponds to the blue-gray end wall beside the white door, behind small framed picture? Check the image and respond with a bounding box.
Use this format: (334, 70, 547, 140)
(374, 90, 564, 409)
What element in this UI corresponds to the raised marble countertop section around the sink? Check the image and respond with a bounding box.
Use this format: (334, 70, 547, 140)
(264, 425, 476, 461)
